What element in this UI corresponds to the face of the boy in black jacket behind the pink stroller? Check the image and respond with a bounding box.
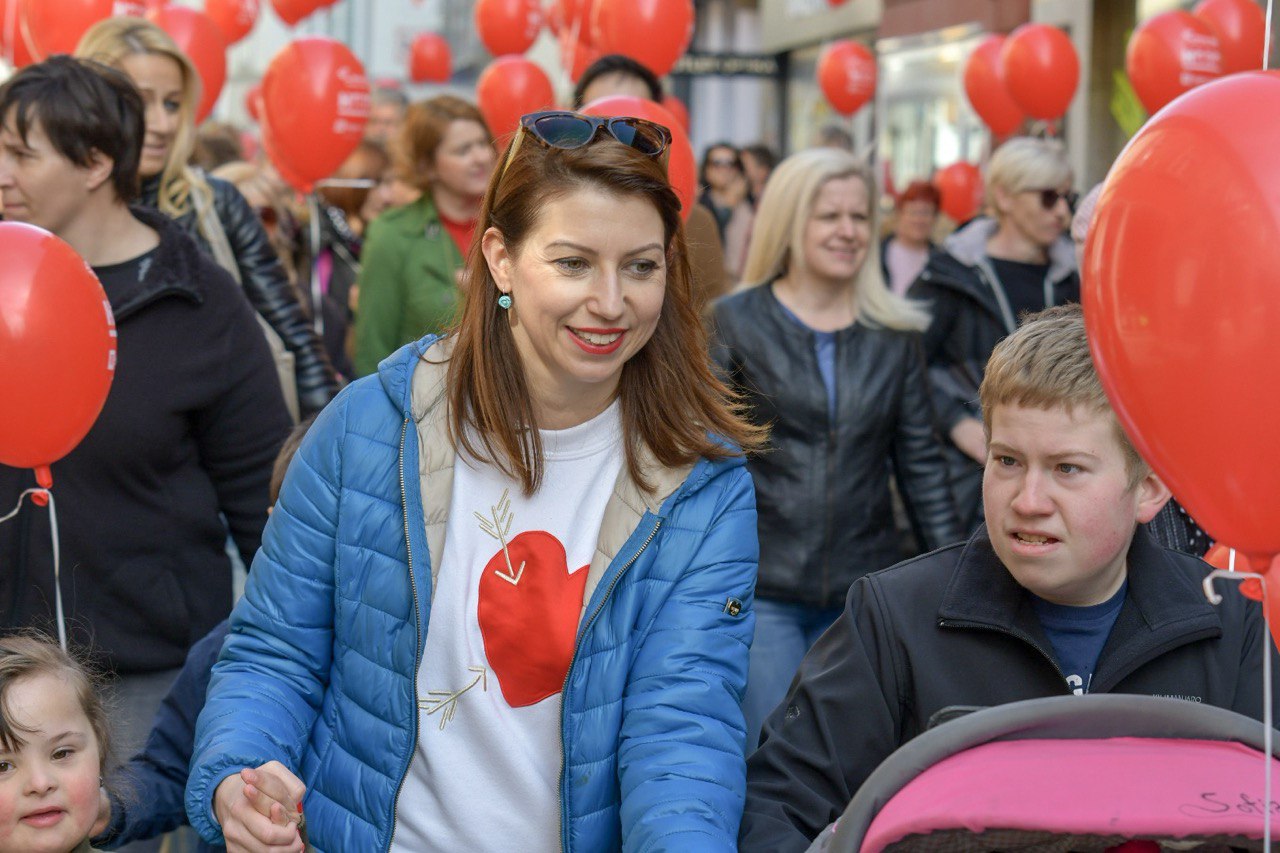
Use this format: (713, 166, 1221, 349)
(982, 405, 1169, 606)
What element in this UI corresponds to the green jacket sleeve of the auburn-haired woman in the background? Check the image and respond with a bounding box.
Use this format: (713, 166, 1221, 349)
(353, 212, 407, 377)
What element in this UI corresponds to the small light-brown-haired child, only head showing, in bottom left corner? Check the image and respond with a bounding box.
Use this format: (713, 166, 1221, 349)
(0, 635, 110, 853)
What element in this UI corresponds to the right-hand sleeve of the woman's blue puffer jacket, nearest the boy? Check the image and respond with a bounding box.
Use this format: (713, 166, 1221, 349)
(618, 469, 759, 853)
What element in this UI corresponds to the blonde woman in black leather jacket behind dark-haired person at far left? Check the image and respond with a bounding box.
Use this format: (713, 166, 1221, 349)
(76, 15, 338, 416)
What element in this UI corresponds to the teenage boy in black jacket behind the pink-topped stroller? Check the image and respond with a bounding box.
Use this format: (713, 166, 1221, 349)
(740, 306, 1275, 853)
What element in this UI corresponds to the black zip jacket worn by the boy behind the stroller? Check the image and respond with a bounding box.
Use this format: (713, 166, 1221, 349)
(740, 528, 1275, 853)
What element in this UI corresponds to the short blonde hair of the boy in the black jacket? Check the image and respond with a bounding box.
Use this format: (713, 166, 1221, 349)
(978, 304, 1151, 489)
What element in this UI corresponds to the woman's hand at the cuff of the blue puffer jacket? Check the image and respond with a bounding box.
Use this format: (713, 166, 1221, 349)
(214, 761, 306, 853)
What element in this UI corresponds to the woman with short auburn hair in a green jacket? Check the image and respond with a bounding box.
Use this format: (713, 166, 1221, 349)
(355, 95, 497, 377)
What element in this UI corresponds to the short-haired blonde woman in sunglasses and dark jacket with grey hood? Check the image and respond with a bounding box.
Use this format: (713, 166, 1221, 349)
(908, 137, 1080, 532)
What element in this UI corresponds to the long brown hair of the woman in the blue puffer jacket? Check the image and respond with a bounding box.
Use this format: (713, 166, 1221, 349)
(448, 132, 768, 493)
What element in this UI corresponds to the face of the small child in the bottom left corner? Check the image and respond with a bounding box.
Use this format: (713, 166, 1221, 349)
(0, 675, 99, 853)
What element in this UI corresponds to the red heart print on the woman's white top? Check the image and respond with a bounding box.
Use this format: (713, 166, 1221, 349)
(476, 493, 588, 708)
